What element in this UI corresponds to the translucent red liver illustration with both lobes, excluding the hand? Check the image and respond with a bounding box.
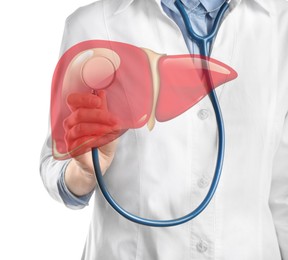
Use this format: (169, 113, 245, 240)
(51, 40, 237, 160)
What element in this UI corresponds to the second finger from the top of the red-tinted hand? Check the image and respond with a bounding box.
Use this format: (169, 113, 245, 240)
(63, 108, 120, 130)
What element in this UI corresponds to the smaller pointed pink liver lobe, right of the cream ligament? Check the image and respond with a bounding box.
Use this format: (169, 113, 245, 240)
(155, 55, 237, 122)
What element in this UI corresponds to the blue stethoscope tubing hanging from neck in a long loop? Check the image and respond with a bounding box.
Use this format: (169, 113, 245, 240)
(92, 0, 229, 227)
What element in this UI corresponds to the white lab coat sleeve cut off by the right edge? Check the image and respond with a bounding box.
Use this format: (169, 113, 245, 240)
(270, 113, 288, 260)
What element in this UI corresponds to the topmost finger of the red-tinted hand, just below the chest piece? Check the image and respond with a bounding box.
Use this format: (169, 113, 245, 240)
(67, 93, 102, 111)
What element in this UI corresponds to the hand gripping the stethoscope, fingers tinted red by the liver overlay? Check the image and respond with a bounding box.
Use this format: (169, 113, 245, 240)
(63, 90, 120, 178)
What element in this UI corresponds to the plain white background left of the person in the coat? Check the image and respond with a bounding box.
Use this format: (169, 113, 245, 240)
(0, 0, 98, 260)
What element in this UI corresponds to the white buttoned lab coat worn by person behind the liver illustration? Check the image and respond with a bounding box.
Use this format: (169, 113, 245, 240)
(41, 0, 288, 260)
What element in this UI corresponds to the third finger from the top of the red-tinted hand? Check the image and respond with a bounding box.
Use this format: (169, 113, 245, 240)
(66, 123, 120, 142)
